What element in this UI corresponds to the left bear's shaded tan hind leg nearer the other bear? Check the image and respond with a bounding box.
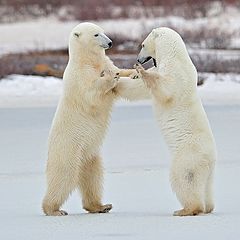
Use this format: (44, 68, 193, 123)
(78, 156, 112, 213)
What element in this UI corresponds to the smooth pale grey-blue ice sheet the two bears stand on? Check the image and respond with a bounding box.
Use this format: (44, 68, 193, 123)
(0, 105, 240, 240)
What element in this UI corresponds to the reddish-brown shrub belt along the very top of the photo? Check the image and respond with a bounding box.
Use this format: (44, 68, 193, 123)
(0, 0, 240, 21)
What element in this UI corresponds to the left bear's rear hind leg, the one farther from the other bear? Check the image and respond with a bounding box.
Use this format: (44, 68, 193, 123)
(42, 162, 76, 216)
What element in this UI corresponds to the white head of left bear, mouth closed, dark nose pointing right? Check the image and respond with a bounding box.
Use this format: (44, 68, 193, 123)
(69, 22, 112, 51)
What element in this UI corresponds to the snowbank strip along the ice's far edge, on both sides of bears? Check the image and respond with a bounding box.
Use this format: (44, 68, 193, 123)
(0, 73, 240, 107)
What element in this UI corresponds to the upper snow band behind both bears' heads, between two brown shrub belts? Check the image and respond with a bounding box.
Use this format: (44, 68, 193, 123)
(0, 8, 240, 55)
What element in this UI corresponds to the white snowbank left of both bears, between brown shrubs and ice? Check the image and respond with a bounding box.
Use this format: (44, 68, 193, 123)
(0, 75, 62, 107)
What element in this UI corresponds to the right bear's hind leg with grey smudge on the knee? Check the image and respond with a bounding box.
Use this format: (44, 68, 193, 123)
(172, 166, 206, 216)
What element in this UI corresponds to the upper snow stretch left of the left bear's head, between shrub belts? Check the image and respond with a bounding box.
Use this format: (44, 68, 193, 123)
(0, 19, 78, 55)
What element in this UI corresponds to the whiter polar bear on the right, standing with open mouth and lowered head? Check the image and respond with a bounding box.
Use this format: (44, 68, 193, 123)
(136, 27, 216, 216)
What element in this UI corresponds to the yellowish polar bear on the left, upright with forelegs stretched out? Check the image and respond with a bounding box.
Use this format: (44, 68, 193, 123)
(42, 23, 150, 216)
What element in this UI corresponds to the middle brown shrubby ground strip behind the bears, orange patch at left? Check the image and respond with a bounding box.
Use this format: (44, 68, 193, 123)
(0, 47, 240, 84)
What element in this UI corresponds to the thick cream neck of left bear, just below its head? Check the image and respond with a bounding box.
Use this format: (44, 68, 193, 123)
(69, 48, 105, 67)
